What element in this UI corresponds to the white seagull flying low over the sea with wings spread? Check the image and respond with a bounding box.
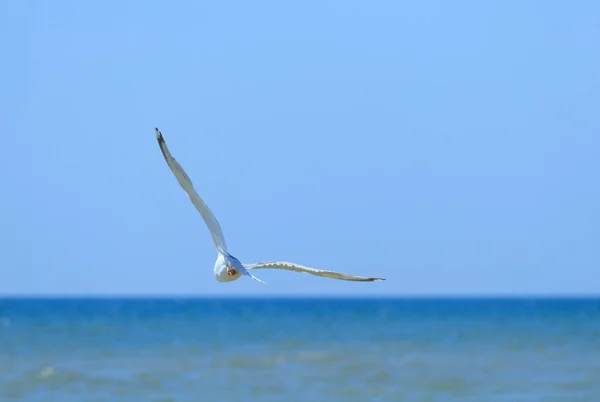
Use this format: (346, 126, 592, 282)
(155, 128, 385, 285)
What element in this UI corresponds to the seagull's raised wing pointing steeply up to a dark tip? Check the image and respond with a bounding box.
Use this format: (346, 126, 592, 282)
(155, 128, 227, 253)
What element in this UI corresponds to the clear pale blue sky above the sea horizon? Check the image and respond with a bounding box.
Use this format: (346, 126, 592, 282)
(0, 0, 600, 297)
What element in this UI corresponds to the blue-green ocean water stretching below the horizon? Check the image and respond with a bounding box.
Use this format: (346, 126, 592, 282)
(0, 298, 600, 402)
